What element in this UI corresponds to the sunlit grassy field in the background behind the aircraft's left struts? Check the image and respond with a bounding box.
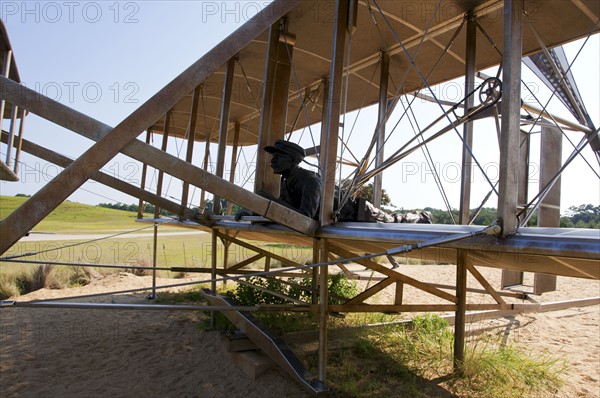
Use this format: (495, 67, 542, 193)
(0, 196, 311, 293)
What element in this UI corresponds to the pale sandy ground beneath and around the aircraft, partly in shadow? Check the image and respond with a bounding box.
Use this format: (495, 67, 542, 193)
(0, 265, 600, 398)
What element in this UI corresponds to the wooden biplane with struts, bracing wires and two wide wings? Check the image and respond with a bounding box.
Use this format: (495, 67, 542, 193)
(0, 0, 600, 393)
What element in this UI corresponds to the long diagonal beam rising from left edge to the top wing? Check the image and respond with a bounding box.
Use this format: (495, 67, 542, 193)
(0, 0, 300, 254)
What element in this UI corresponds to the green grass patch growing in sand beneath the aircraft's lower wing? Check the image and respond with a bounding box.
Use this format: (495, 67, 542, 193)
(316, 315, 565, 398)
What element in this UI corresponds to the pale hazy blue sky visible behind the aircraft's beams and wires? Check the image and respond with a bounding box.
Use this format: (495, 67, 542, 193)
(0, 1, 600, 210)
